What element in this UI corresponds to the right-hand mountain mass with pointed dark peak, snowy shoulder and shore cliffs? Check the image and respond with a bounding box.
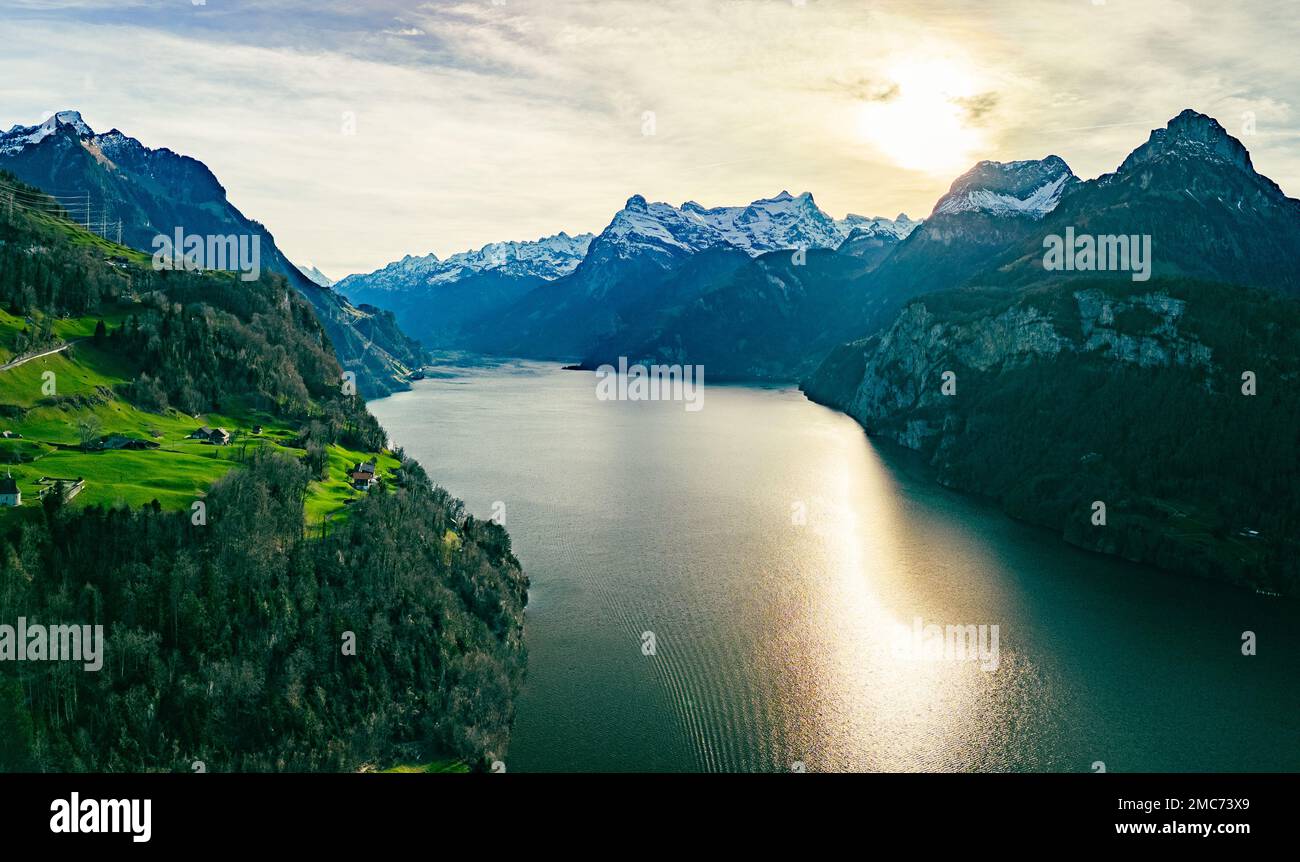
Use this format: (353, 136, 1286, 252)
(803, 111, 1300, 594)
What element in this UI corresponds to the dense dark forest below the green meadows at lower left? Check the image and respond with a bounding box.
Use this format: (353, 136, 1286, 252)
(0, 456, 528, 772)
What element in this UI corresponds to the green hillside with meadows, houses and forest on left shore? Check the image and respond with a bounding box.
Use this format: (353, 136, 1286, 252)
(0, 177, 528, 772)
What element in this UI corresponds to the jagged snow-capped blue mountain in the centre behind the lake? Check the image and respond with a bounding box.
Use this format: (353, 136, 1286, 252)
(463, 191, 914, 365)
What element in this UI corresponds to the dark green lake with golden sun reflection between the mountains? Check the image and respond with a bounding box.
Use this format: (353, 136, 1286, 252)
(371, 364, 1300, 772)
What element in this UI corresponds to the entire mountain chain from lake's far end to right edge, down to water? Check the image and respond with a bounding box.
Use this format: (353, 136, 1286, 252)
(341, 111, 1300, 594)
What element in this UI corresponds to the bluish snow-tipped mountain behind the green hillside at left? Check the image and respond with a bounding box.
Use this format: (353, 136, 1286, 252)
(0, 111, 425, 397)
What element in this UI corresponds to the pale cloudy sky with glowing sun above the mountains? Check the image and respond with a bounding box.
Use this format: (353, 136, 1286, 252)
(0, 0, 1300, 278)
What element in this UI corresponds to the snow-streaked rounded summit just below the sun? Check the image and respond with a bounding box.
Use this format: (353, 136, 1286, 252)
(935, 156, 1079, 218)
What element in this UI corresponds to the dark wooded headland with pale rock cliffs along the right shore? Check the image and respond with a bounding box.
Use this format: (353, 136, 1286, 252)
(803, 282, 1300, 593)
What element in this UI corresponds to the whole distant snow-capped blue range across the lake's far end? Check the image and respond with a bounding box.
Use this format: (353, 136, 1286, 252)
(337, 191, 919, 366)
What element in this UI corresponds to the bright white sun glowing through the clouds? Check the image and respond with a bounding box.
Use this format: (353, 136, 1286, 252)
(858, 60, 984, 176)
